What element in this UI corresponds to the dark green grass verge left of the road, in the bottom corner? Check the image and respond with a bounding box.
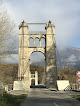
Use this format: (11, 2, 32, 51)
(0, 94, 27, 106)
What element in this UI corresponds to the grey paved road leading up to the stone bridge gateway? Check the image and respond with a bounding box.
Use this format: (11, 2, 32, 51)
(20, 88, 80, 106)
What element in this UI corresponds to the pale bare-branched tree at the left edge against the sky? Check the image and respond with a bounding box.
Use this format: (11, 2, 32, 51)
(0, 0, 16, 62)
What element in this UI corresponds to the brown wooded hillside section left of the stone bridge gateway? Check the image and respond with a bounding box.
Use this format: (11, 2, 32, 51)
(0, 64, 18, 85)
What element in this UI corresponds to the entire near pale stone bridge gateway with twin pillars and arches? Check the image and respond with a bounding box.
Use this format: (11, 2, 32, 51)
(18, 21, 57, 88)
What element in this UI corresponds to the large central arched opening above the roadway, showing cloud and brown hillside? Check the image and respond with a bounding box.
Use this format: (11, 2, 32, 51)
(30, 52, 45, 85)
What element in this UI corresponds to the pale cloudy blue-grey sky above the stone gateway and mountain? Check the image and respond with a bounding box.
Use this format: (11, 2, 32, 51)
(3, 0, 80, 63)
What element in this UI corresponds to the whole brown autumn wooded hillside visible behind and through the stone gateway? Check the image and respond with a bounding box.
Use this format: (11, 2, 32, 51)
(0, 64, 79, 85)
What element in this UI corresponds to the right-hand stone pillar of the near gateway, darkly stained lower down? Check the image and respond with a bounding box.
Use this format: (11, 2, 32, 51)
(45, 21, 57, 88)
